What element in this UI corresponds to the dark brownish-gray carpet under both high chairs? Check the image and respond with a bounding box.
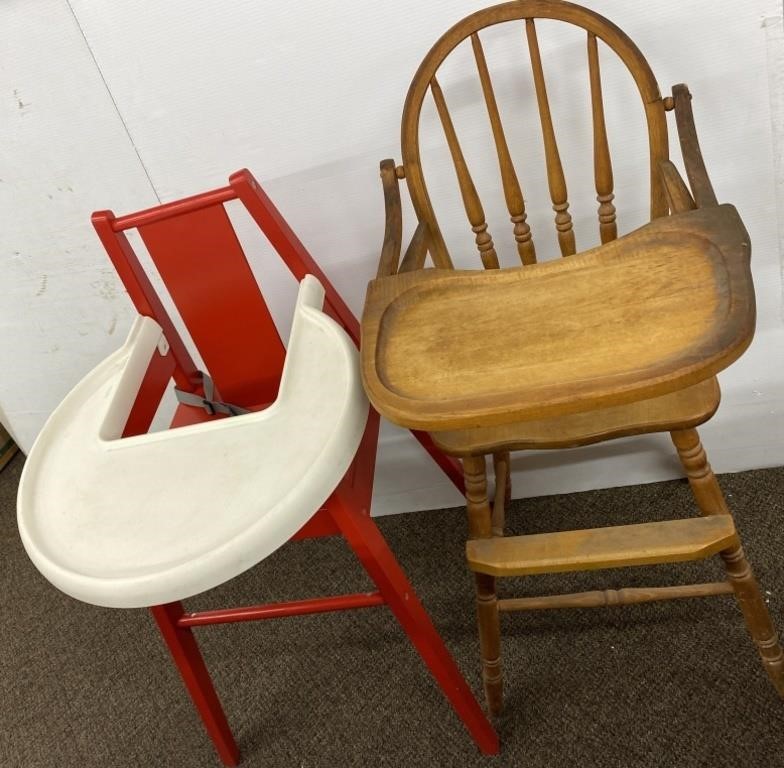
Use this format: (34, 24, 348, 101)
(0, 456, 784, 768)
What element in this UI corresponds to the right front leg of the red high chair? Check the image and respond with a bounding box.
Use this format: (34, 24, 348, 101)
(329, 493, 499, 755)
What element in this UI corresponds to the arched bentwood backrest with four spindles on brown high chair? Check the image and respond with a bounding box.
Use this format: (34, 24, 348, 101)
(401, 0, 668, 268)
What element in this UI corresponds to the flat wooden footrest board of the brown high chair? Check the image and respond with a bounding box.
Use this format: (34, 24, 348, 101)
(466, 515, 737, 576)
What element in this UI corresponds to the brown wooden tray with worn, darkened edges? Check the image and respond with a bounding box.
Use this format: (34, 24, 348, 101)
(361, 205, 755, 430)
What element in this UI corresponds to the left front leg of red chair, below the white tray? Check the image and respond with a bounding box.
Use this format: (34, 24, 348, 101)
(150, 602, 240, 765)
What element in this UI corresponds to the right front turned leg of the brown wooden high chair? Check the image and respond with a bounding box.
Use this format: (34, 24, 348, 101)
(672, 429, 784, 698)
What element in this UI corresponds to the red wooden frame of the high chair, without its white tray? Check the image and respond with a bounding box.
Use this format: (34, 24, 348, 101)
(92, 170, 499, 765)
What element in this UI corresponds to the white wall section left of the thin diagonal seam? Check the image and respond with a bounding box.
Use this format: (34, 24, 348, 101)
(0, 0, 156, 450)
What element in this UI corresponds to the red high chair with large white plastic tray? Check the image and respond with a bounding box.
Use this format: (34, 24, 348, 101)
(18, 171, 498, 765)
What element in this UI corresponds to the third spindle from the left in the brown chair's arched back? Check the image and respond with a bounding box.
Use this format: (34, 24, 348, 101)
(525, 19, 577, 256)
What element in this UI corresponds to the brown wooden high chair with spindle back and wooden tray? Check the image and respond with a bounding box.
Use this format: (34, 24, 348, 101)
(361, 0, 784, 728)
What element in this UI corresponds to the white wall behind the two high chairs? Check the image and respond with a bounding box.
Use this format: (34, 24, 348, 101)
(0, 0, 784, 513)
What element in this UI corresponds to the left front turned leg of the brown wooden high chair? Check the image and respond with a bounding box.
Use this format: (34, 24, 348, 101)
(463, 456, 503, 715)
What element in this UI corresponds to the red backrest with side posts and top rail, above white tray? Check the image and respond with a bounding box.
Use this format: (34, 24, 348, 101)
(92, 170, 359, 406)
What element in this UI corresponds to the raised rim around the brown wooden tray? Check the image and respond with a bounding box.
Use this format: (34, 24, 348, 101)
(361, 204, 755, 431)
